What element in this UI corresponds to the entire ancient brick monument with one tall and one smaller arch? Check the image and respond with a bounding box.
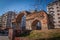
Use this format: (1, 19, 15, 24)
(14, 11, 48, 30)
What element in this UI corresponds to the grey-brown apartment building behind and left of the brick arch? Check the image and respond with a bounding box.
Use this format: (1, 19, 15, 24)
(2, 11, 16, 28)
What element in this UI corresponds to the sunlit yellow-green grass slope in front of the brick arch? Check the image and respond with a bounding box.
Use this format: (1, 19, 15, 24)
(28, 30, 60, 39)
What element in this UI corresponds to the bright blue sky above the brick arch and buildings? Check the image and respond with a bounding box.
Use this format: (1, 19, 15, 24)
(0, 0, 53, 15)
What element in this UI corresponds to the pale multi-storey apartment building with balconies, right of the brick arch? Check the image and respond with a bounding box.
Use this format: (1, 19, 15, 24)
(47, 0, 60, 28)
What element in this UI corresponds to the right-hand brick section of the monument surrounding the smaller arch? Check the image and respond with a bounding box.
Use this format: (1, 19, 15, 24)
(26, 11, 48, 30)
